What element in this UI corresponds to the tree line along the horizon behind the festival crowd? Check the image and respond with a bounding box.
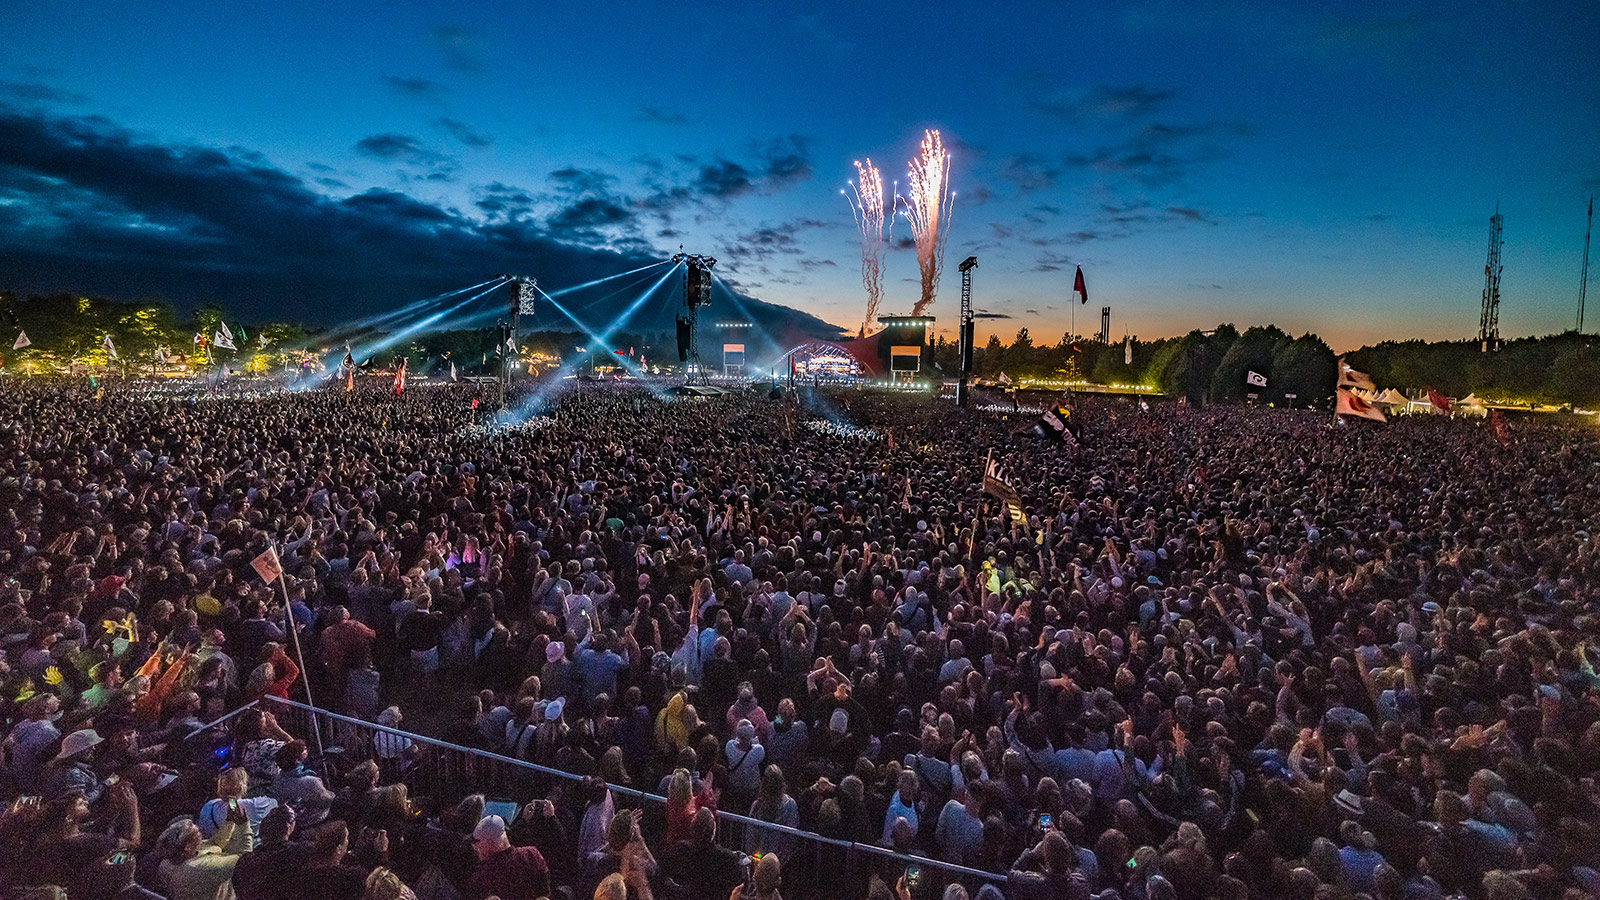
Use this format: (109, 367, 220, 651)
(9, 293, 1600, 408)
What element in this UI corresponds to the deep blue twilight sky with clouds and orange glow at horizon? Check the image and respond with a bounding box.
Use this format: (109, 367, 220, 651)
(0, 0, 1600, 349)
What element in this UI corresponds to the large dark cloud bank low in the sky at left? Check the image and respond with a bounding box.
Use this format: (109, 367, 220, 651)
(0, 107, 837, 336)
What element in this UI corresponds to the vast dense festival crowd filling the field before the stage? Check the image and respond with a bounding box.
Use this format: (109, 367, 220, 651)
(0, 380, 1600, 900)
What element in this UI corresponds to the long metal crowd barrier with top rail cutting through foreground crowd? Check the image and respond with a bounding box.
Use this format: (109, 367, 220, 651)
(189, 697, 1005, 898)
